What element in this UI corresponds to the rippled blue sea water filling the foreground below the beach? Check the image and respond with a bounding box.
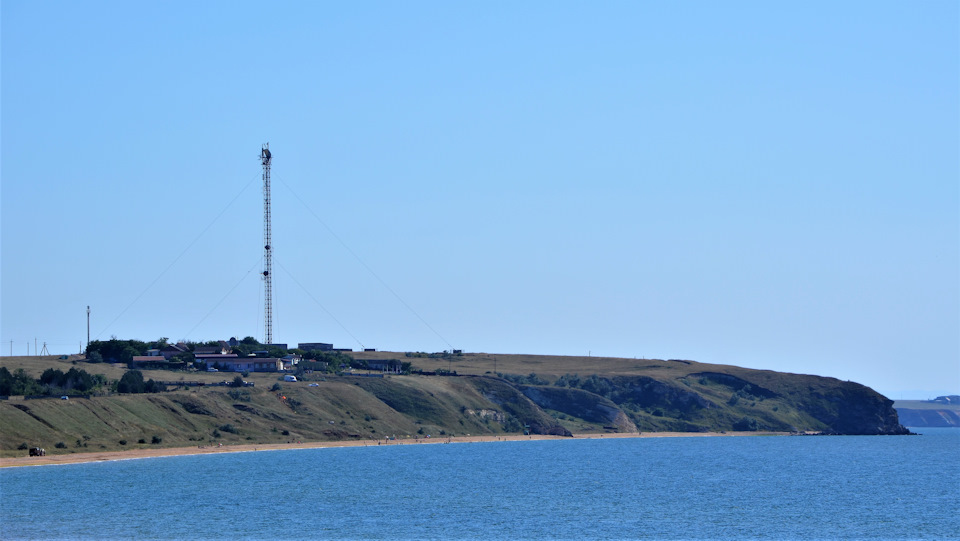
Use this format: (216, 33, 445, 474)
(0, 429, 960, 539)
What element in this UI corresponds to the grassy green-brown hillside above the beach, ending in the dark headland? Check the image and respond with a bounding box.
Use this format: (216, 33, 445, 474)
(0, 352, 906, 456)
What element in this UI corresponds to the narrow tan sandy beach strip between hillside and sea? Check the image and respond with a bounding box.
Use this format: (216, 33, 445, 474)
(0, 432, 790, 468)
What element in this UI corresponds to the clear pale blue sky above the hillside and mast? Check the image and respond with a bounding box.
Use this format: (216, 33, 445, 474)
(0, 0, 960, 398)
